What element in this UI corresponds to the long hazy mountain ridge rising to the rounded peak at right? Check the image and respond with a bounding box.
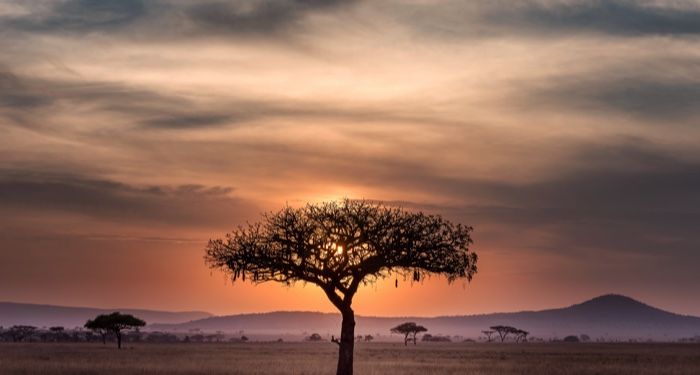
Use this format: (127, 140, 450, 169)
(150, 294, 700, 340)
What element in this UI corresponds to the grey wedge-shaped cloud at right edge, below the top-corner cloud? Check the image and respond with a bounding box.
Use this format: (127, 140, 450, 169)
(504, 58, 700, 122)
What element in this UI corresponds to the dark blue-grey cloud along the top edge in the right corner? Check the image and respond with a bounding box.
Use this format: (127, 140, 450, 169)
(399, 0, 700, 38)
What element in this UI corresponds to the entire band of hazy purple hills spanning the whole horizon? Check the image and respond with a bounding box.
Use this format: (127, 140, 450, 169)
(5, 294, 700, 341)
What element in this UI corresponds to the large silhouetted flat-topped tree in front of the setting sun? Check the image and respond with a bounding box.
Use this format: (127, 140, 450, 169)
(205, 199, 477, 375)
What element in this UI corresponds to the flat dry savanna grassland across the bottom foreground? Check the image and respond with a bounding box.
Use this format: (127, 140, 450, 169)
(0, 342, 700, 375)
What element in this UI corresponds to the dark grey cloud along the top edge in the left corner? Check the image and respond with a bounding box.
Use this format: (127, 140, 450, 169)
(0, 0, 352, 39)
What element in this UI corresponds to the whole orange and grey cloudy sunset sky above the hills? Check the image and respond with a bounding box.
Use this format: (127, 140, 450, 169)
(0, 0, 700, 316)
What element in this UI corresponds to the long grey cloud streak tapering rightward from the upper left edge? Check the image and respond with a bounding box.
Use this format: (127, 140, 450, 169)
(0, 70, 474, 130)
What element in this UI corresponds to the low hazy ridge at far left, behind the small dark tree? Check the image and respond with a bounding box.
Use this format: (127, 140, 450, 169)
(0, 302, 212, 328)
